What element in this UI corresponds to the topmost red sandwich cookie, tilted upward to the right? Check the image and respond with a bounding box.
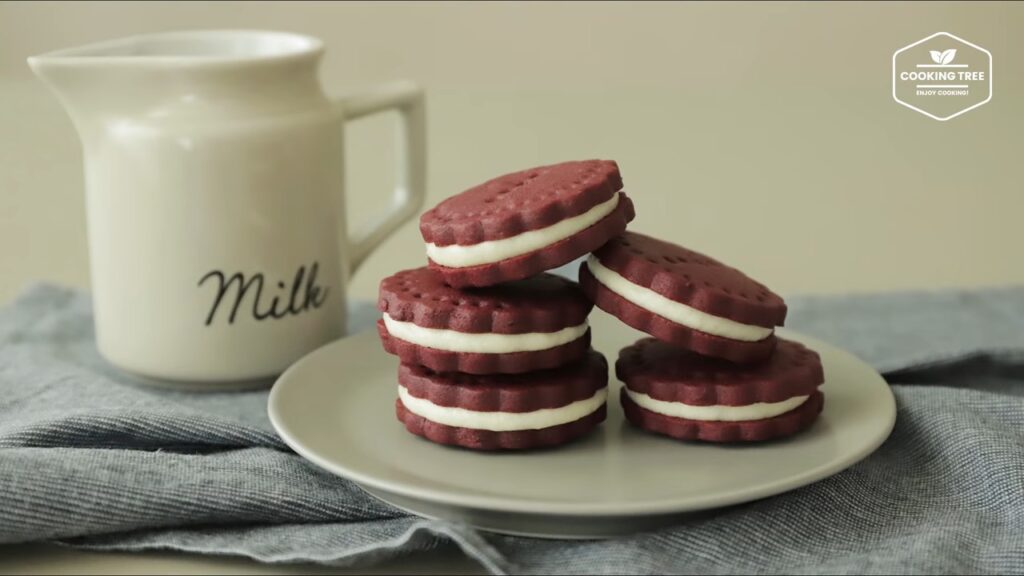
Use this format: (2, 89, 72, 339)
(420, 160, 634, 287)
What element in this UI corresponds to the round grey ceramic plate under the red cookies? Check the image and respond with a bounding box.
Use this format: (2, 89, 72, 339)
(268, 311, 896, 538)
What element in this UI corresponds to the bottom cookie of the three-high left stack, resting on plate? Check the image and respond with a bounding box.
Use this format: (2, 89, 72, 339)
(395, 351, 608, 450)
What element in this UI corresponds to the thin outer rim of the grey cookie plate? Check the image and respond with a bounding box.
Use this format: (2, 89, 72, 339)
(267, 329, 896, 517)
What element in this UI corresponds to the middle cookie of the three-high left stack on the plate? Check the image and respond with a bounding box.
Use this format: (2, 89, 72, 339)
(377, 268, 594, 374)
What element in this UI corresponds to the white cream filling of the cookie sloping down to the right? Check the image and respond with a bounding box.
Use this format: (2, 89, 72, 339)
(587, 254, 772, 342)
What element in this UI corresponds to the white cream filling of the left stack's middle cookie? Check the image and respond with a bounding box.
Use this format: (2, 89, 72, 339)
(384, 313, 588, 354)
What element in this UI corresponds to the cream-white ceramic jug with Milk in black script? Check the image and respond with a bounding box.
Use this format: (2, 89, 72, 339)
(29, 31, 426, 385)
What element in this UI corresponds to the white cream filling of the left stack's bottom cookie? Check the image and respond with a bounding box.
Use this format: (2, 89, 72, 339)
(398, 385, 608, 431)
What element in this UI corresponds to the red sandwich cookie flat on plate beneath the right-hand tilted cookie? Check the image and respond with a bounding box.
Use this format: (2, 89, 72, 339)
(615, 338, 824, 443)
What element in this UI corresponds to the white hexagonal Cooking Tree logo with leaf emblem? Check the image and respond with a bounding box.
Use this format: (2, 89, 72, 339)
(893, 32, 992, 122)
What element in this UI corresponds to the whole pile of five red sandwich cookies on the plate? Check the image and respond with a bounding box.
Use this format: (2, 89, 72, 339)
(378, 160, 824, 450)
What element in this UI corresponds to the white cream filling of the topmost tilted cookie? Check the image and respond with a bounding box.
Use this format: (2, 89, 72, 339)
(427, 192, 620, 268)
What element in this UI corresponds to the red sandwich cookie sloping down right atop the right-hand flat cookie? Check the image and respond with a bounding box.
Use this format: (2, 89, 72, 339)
(580, 232, 786, 363)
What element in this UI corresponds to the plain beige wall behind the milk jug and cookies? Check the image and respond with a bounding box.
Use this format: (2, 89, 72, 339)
(0, 2, 1024, 301)
